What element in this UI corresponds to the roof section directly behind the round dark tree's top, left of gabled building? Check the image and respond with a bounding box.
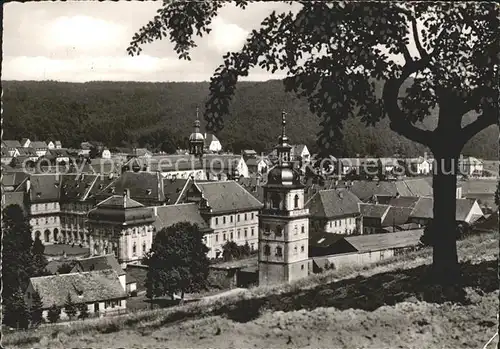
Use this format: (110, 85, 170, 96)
(154, 203, 209, 231)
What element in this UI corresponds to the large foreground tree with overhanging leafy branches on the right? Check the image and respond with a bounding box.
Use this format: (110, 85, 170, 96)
(128, 1, 500, 284)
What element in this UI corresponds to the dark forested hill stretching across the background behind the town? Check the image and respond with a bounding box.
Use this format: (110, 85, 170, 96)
(3, 80, 498, 159)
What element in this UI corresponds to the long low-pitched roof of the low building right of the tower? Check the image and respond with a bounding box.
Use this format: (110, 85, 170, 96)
(344, 229, 423, 253)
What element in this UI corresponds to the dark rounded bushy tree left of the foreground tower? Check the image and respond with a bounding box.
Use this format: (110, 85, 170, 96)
(143, 222, 209, 298)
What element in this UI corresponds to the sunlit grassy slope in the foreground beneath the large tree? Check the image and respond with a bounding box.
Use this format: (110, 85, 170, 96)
(2, 234, 498, 348)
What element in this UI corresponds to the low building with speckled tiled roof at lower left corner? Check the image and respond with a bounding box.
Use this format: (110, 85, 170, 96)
(25, 269, 127, 320)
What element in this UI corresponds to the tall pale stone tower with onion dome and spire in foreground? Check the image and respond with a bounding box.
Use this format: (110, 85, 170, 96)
(259, 112, 309, 285)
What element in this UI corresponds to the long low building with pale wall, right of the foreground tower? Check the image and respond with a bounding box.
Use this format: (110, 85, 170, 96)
(310, 229, 423, 273)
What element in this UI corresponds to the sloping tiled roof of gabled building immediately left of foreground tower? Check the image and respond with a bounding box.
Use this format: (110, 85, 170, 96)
(195, 181, 263, 213)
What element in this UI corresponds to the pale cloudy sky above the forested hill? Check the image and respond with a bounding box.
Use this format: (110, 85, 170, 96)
(2, 1, 300, 82)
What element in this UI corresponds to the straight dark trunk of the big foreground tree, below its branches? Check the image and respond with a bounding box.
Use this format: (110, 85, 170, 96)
(432, 155, 460, 285)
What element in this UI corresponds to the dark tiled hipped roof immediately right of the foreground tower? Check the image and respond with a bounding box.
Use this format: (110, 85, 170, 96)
(306, 188, 361, 218)
